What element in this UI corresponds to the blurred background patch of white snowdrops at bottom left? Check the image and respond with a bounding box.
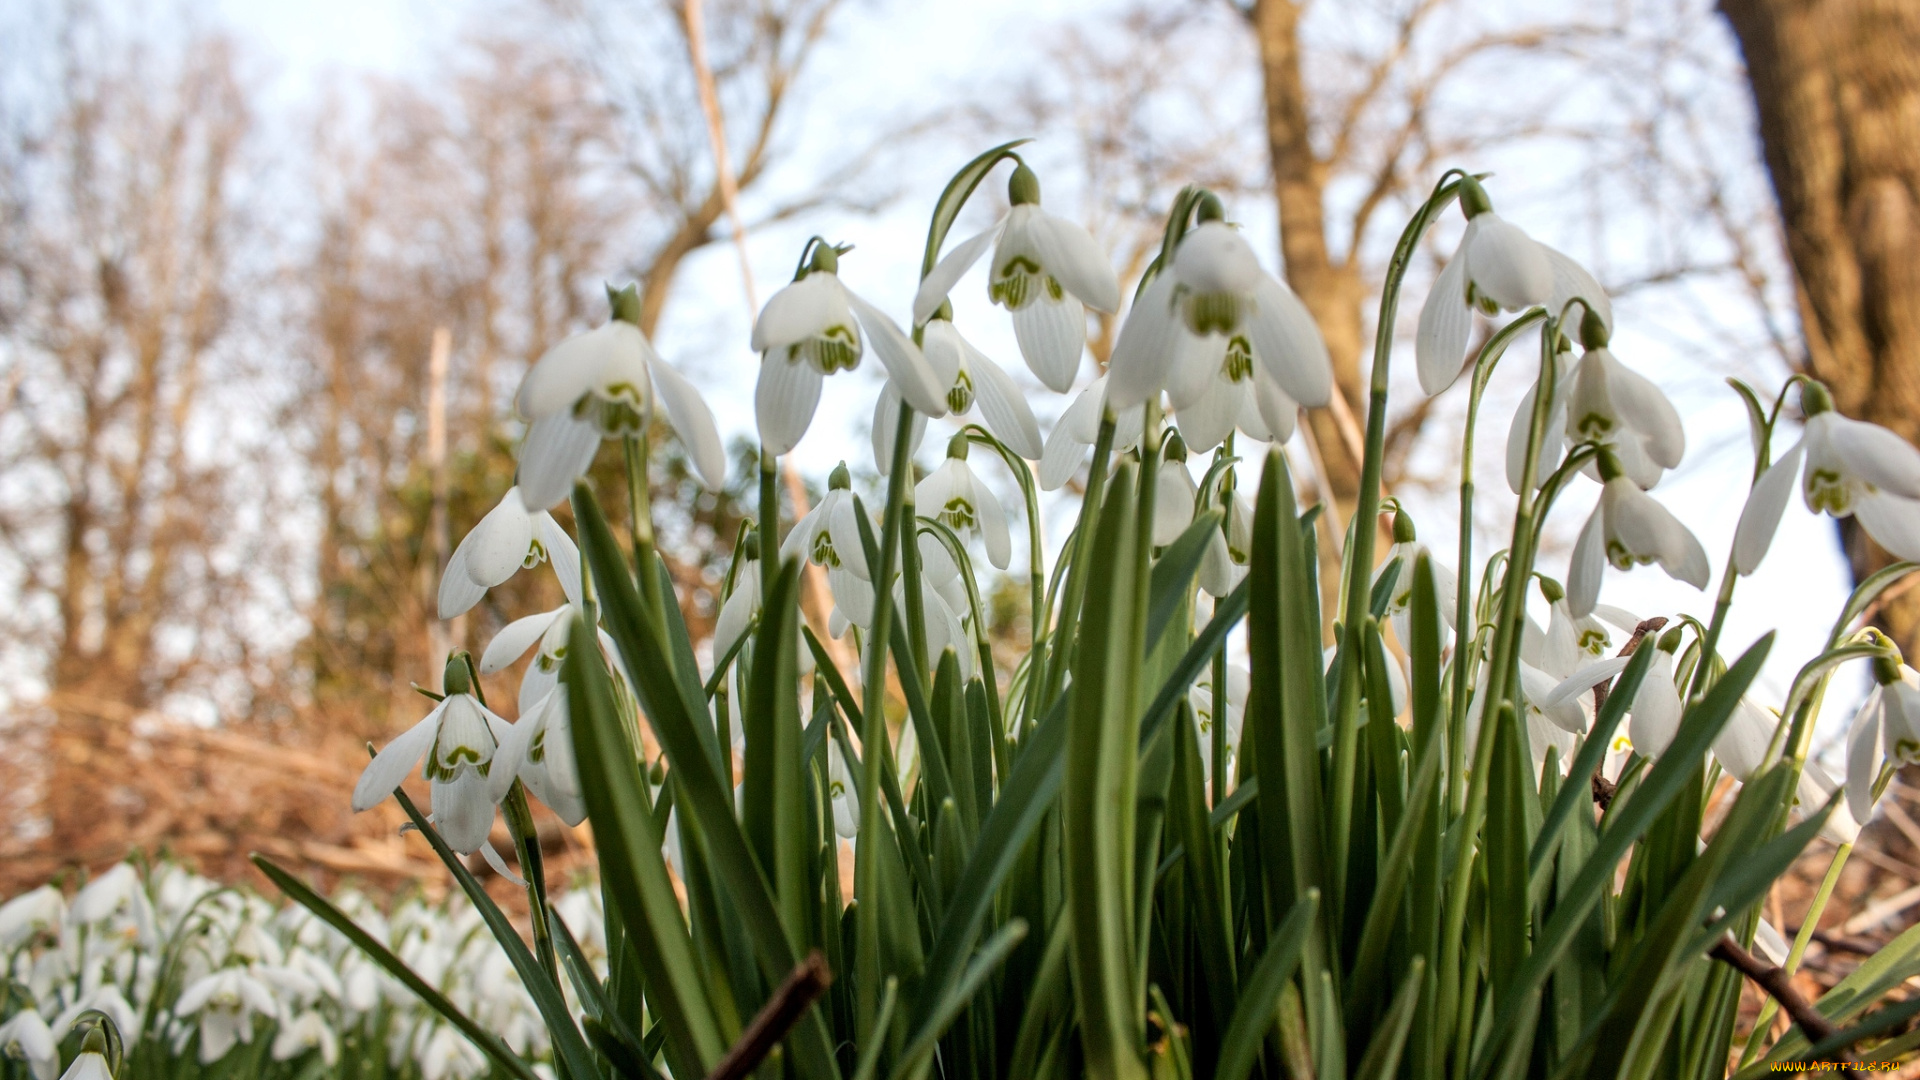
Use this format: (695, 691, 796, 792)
(0, 863, 605, 1080)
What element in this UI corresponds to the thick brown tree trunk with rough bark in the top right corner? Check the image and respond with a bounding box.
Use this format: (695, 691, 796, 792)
(1720, 0, 1920, 645)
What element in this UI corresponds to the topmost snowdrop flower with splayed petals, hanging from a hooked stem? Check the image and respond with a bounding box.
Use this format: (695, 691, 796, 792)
(914, 161, 1119, 392)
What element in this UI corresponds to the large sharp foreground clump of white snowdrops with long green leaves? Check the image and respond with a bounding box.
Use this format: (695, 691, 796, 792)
(161, 144, 1920, 1080)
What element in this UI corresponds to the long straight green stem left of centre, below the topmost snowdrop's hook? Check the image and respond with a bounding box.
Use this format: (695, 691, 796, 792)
(860, 402, 914, 1045)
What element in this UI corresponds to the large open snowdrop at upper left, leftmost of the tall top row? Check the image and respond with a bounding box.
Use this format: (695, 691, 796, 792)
(515, 284, 726, 507)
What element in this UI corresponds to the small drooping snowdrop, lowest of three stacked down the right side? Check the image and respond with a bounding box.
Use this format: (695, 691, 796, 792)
(1567, 450, 1713, 615)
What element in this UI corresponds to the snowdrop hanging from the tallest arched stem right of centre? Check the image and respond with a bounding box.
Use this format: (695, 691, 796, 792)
(1413, 177, 1566, 398)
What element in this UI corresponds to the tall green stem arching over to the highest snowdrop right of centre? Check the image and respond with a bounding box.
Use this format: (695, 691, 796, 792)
(1327, 169, 1459, 899)
